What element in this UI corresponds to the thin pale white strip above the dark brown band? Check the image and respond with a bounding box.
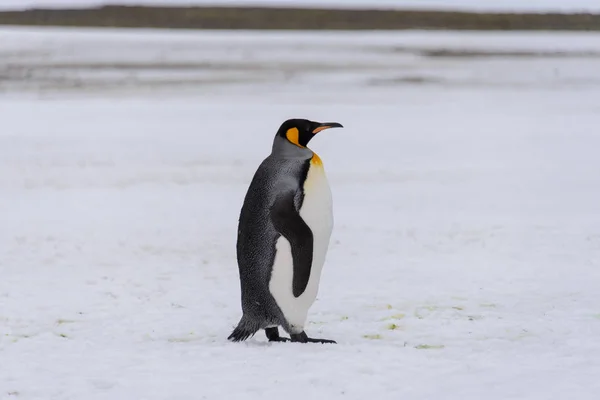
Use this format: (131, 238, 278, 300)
(0, 0, 600, 12)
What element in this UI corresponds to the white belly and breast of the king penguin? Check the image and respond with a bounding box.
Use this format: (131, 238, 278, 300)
(269, 163, 333, 333)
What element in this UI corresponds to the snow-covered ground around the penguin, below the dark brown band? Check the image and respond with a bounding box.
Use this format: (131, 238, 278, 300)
(0, 29, 600, 400)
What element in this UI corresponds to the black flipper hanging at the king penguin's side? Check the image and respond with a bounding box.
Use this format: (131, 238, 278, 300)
(271, 191, 313, 297)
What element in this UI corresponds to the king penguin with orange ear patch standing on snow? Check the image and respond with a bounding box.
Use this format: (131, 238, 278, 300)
(228, 119, 342, 343)
